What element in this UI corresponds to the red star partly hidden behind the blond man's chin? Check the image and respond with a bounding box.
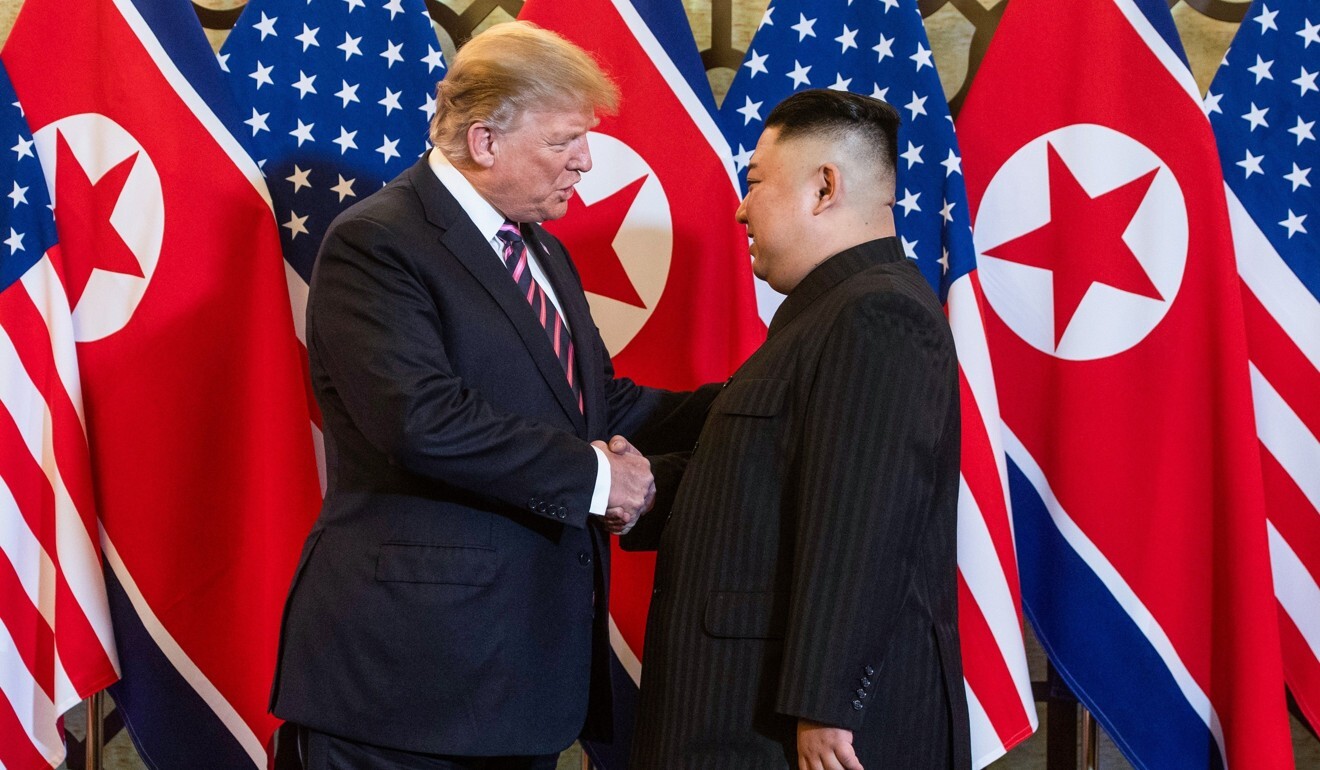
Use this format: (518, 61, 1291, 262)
(545, 176, 648, 308)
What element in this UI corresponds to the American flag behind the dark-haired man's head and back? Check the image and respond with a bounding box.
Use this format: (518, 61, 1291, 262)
(721, 0, 1036, 767)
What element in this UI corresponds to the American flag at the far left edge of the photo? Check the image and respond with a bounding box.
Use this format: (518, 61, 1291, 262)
(0, 58, 119, 770)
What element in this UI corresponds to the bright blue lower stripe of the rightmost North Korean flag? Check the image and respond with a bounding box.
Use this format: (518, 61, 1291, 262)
(1008, 460, 1224, 770)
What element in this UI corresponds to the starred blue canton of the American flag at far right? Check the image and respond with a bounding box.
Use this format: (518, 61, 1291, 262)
(1205, 0, 1320, 300)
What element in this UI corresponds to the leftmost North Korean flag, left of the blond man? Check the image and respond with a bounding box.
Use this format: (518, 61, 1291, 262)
(3, 0, 319, 770)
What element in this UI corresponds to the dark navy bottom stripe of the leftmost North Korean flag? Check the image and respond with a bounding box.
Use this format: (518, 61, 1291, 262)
(106, 565, 253, 770)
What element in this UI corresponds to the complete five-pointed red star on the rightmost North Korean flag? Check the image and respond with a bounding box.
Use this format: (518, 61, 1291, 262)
(986, 144, 1164, 347)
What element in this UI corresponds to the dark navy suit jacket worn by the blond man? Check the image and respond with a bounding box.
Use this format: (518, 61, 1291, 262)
(271, 160, 709, 755)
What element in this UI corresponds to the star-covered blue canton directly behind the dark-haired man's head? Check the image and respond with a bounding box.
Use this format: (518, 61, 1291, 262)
(719, 0, 975, 301)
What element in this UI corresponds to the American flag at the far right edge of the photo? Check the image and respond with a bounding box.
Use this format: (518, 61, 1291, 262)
(1205, 0, 1320, 725)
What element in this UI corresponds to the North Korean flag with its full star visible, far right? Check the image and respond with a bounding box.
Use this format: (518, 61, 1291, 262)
(958, 0, 1291, 769)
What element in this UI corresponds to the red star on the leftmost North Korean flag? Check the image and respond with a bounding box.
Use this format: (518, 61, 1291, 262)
(55, 131, 144, 308)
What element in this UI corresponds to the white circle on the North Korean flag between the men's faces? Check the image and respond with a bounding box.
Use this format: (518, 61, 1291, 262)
(577, 131, 673, 355)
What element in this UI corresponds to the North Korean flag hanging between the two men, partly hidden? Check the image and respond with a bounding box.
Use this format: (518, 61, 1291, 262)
(519, 0, 766, 767)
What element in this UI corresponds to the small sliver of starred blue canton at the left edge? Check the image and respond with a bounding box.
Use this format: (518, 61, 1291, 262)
(0, 66, 57, 292)
